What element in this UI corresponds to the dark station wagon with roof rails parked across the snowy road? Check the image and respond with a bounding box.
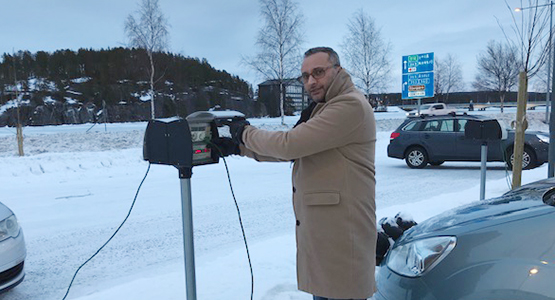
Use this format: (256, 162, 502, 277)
(387, 114, 549, 170)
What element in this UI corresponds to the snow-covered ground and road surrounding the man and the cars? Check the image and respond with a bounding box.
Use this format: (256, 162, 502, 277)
(0, 109, 548, 300)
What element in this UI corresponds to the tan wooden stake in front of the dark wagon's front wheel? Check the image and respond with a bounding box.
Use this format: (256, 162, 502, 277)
(508, 72, 528, 189)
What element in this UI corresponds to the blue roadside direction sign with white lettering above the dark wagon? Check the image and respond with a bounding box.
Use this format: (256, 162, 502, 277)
(401, 52, 434, 99)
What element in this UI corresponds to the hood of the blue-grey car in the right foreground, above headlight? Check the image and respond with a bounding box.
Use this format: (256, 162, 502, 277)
(398, 179, 555, 242)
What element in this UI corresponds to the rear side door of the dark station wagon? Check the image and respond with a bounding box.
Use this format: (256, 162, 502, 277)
(420, 119, 456, 161)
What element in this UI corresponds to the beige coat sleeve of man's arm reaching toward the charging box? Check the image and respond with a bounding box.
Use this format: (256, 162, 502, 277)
(243, 94, 369, 160)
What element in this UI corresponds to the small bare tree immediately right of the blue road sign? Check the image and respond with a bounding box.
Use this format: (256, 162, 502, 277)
(434, 54, 464, 102)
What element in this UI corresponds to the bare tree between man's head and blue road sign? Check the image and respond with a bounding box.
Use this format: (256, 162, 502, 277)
(341, 9, 391, 105)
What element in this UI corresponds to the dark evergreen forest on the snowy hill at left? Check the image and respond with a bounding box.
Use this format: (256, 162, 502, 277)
(0, 48, 265, 126)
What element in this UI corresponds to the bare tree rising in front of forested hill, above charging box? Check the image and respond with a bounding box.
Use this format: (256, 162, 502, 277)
(125, 0, 169, 119)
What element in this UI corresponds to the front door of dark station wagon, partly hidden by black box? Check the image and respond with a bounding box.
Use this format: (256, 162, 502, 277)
(455, 118, 501, 161)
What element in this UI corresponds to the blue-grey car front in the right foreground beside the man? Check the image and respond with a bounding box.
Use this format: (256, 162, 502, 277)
(372, 178, 555, 300)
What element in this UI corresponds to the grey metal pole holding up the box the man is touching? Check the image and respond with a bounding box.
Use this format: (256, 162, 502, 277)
(179, 168, 197, 300)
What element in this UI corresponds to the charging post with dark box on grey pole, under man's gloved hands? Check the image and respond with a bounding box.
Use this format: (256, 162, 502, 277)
(143, 111, 245, 300)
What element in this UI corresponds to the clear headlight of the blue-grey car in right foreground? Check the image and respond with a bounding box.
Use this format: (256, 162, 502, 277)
(387, 236, 457, 277)
